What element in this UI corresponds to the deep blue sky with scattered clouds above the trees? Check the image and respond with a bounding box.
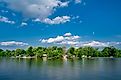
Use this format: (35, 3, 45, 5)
(0, 0, 121, 49)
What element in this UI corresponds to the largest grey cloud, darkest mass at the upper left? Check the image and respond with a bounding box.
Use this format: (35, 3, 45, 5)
(0, 0, 69, 19)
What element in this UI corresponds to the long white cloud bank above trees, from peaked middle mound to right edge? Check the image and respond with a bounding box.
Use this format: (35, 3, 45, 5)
(40, 33, 121, 48)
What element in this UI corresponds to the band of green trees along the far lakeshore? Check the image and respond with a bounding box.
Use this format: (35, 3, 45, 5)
(0, 46, 121, 58)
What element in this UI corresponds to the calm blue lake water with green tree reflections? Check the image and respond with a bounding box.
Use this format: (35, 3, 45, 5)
(0, 58, 121, 80)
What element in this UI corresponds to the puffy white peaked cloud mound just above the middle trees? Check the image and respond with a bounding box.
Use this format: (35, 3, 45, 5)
(40, 33, 80, 45)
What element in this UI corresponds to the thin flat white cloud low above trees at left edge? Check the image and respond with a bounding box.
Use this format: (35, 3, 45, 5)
(0, 41, 28, 46)
